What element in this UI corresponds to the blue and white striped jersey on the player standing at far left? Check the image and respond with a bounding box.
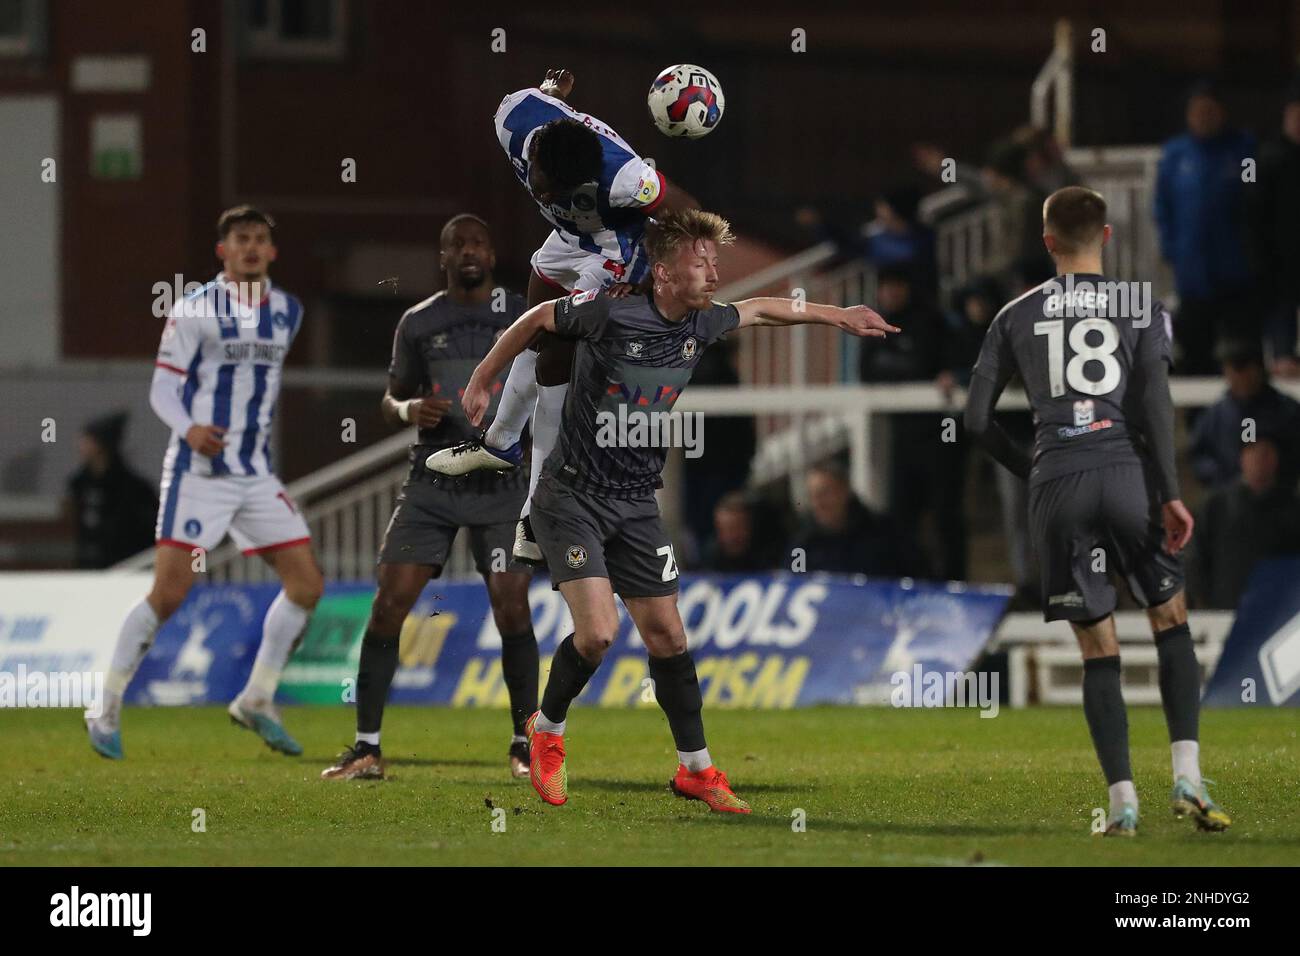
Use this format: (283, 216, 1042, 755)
(157, 276, 303, 476)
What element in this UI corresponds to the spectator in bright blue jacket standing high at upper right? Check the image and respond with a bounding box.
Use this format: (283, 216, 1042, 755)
(1156, 81, 1258, 375)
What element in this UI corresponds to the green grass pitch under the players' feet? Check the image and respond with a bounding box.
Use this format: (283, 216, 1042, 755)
(0, 708, 1300, 866)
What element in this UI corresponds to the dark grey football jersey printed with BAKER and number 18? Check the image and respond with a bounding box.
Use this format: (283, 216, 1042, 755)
(974, 273, 1173, 484)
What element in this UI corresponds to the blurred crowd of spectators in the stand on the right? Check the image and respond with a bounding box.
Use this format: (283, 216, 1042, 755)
(688, 78, 1300, 607)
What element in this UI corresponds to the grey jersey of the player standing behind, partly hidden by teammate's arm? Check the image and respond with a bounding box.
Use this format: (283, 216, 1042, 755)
(389, 291, 527, 449)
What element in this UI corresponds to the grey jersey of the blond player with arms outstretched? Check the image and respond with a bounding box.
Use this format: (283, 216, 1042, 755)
(542, 291, 740, 498)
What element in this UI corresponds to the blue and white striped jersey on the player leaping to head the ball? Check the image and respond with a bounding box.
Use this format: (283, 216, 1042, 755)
(495, 88, 664, 263)
